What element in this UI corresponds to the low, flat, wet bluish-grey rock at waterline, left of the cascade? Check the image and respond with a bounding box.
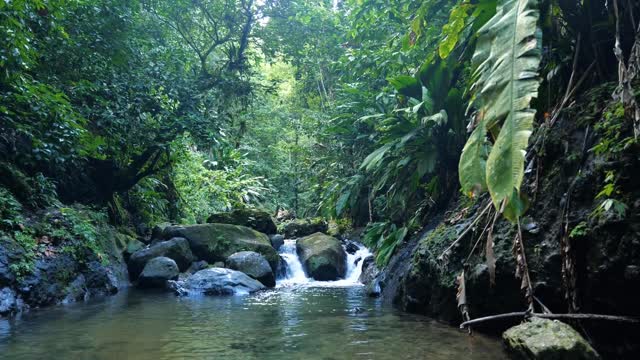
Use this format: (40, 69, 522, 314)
(169, 268, 265, 296)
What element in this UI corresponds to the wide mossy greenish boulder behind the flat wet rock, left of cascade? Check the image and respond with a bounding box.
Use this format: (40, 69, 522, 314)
(164, 224, 278, 270)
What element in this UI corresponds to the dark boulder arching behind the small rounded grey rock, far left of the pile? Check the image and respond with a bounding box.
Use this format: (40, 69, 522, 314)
(129, 237, 196, 279)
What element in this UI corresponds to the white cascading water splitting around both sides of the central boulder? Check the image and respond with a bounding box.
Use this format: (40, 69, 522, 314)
(277, 240, 371, 287)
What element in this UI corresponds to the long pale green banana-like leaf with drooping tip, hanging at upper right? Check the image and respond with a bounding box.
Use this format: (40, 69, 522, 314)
(460, 0, 541, 207)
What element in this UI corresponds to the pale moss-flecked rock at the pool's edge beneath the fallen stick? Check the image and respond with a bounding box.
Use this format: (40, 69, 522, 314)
(502, 318, 599, 360)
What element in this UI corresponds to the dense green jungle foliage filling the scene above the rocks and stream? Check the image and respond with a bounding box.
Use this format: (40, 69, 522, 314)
(0, 0, 640, 270)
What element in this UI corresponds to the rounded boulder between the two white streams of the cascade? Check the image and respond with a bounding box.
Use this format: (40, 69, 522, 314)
(296, 233, 347, 281)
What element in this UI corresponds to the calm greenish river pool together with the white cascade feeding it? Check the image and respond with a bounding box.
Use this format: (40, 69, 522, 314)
(0, 242, 505, 360)
